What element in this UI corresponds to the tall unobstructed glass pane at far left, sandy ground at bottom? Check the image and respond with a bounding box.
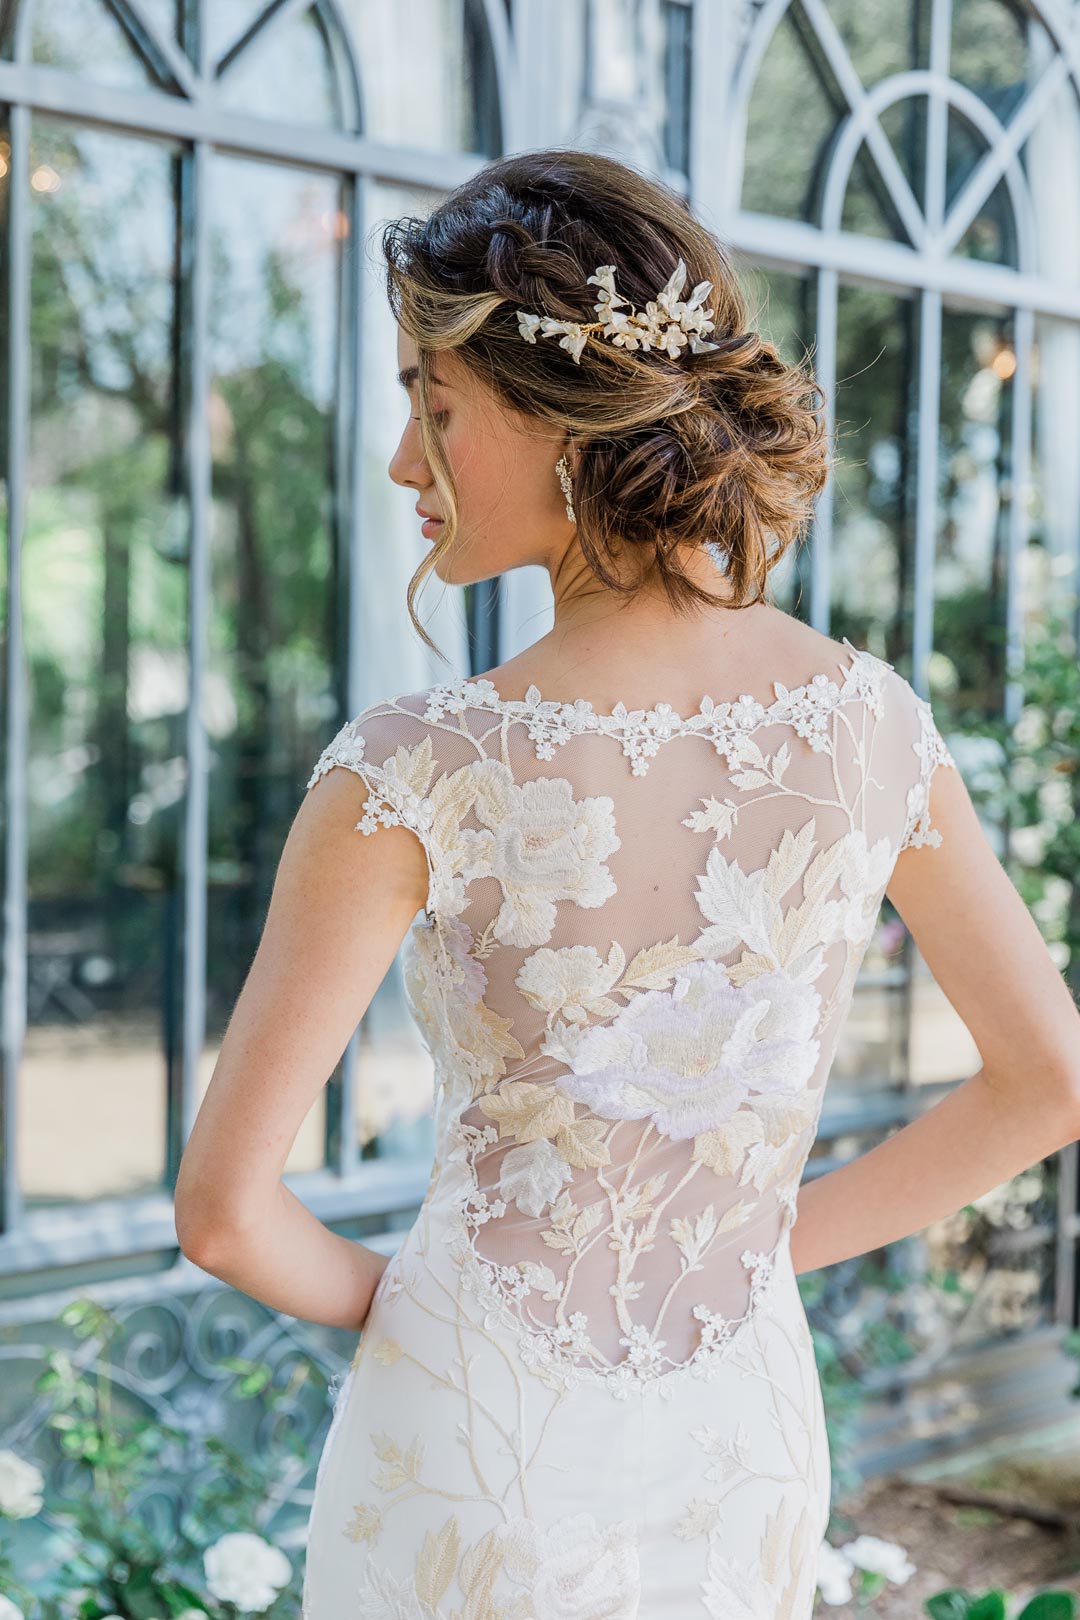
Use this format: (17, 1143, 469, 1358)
(18, 118, 188, 1204)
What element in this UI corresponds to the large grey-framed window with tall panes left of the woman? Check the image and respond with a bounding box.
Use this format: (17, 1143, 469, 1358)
(0, 0, 508, 1267)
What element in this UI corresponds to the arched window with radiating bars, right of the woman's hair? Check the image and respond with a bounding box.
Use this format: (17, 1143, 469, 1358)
(717, 0, 1080, 1341)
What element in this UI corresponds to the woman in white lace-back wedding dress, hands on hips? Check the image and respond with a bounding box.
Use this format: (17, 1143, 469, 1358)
(176, 151, 1080, 1620)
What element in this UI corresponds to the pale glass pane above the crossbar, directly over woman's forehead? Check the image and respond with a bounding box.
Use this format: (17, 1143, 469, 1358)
(337, 0, 501, 157)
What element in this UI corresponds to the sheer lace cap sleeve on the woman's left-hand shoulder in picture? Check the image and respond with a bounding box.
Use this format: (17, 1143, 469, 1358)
(308, 698, 439, 915)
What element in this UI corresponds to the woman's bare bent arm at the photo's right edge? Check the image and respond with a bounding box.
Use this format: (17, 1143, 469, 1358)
(790, 751, 1080, 1272)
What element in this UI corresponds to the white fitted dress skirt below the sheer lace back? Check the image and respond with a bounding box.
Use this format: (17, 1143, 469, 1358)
(303, 1189, 831, 1620)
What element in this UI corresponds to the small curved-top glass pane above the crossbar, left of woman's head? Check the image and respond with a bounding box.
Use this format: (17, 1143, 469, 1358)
(220, 10, 342, 126)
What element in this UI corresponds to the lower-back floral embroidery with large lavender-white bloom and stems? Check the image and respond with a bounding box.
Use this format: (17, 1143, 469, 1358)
(430, 961, 821, 1395)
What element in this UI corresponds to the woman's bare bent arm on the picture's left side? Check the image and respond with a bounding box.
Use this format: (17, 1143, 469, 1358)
(175, 768, 427, 1330)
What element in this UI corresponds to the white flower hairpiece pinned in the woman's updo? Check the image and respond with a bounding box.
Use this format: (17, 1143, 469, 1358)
(518, 259, 721, 365)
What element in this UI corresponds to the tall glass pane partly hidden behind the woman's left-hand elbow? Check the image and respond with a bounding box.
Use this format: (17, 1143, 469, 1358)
(199, 156, 345, 1171)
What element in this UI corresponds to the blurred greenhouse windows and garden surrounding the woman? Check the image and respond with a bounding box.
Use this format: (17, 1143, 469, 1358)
(0, 0, 1080, 1620)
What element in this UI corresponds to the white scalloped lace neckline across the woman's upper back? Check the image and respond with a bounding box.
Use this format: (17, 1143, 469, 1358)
(431, 637, 892, 734)
